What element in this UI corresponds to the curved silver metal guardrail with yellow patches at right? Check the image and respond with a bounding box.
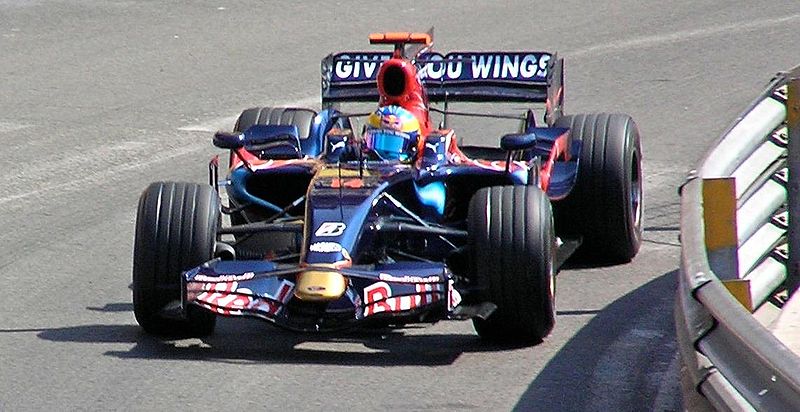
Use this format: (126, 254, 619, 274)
(675, 66, 800, 411)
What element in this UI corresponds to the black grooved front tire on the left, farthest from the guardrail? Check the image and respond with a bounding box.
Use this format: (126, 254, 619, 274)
(133, 182, 220, 336)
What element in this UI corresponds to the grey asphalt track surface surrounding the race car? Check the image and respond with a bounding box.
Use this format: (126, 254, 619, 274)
(0, 0, 800, 411)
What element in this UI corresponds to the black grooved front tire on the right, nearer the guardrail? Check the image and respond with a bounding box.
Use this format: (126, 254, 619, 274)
(468, 186, 556, 344)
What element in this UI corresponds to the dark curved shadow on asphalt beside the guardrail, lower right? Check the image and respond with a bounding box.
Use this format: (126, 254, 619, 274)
(515, 271, 682, 412)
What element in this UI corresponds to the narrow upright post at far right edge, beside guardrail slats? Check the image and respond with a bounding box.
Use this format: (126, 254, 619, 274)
(786, 71, 800, 295)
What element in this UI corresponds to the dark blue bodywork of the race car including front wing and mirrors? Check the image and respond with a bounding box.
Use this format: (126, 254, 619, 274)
(194, 104, 581, 331)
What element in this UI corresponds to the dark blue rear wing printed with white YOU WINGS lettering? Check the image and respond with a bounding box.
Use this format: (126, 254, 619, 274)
(321, 52, 564, 108)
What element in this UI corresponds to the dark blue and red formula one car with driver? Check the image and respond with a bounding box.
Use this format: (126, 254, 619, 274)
(133, 31, 642, 343)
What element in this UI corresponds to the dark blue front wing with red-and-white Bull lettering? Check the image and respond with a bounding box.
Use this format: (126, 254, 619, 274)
(181, 259, 461, 331)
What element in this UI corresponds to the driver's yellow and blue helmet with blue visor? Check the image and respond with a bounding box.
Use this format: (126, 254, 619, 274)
(364, 106, 420, 162)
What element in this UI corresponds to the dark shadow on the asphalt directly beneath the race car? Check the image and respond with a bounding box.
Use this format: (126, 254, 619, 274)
(37, 312, 519, 367)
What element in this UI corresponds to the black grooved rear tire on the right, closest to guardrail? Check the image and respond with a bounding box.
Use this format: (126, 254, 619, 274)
(553, 113, 643, 263)
